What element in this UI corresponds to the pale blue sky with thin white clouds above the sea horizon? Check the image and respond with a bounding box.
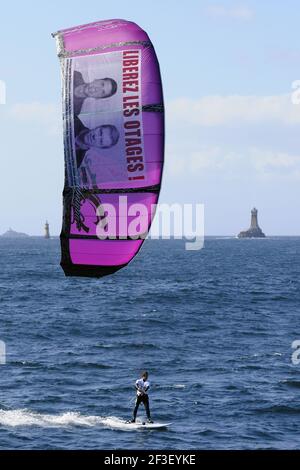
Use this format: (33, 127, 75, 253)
(0, 0, 300, 235)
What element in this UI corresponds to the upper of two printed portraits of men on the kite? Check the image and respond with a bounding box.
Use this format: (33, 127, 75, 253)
(73, 71, 118, 115)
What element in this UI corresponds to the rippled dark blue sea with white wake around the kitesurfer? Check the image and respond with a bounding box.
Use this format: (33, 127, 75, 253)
(0, 238, 300, 449)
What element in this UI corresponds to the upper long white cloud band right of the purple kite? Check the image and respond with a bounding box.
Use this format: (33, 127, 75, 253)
(167, 94, 300, 127)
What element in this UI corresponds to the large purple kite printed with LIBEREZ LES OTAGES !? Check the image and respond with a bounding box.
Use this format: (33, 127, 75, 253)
(53, 20, 164, 277)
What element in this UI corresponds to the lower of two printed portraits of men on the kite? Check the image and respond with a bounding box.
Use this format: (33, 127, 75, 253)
(74, 116, 120, 168)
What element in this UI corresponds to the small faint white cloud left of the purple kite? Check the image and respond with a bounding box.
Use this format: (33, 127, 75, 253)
(8, 101, 62, 135)
